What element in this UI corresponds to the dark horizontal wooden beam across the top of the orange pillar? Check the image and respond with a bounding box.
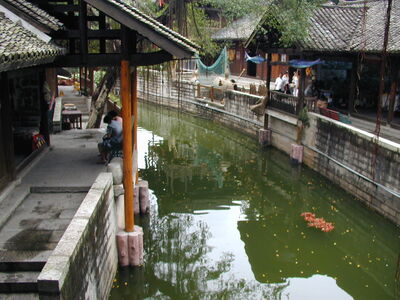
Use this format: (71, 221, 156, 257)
(54, 50, 173, 67)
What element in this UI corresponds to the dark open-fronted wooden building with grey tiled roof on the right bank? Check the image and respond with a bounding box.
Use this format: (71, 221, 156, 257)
(246, 0, 400, 126)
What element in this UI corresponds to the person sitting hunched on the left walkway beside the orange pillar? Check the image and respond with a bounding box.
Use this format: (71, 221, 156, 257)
(98, 114, 122, 163)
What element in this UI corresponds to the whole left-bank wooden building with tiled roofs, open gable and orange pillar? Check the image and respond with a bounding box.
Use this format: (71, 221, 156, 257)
(0, 0, 199, 195)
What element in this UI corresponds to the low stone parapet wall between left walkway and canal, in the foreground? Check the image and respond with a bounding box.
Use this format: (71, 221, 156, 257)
(38, 173, 118, 300)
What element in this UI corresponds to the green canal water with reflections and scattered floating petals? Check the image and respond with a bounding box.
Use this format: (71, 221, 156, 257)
(110, 104, 400, 300)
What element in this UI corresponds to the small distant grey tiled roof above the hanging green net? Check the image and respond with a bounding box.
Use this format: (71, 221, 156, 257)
(211, 16, 261, 41)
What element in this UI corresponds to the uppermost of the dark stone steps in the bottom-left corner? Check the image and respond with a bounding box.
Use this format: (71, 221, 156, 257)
(0, 250, 52, 272)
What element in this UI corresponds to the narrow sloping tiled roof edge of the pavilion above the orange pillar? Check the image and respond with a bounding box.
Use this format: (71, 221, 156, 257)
(92, 0, 200, 53)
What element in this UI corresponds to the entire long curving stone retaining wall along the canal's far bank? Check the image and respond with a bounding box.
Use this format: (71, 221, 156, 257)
(139, 70, 400, 225)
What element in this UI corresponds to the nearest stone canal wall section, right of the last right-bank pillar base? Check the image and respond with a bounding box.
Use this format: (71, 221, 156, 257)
(305, 115, 400, 224)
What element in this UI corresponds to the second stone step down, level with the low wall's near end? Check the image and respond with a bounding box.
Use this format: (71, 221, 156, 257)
(0, 272, 40, 293)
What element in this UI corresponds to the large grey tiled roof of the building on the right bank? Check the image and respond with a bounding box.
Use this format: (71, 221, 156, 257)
(246, 0, 400, 53)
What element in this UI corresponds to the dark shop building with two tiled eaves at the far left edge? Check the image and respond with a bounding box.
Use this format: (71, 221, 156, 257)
(0, 1, 64, 189)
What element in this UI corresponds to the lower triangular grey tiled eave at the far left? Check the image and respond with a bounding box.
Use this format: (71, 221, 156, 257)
(0, 13, 64, 72)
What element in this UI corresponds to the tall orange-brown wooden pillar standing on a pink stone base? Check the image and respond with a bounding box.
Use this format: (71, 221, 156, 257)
(121, 60, 134, 232)
